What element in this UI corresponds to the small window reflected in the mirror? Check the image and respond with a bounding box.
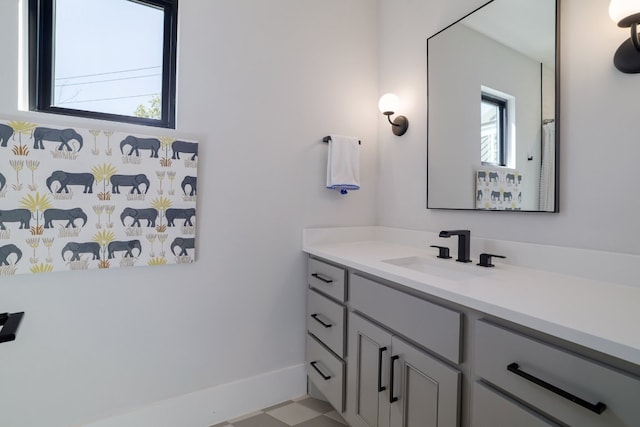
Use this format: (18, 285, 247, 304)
(480, 92, 508, 166)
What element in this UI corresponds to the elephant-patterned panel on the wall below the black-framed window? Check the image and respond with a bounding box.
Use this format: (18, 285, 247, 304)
(0, 120, 198, 276)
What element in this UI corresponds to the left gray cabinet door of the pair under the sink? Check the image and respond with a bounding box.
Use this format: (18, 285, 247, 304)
(347, 314, 391, 427)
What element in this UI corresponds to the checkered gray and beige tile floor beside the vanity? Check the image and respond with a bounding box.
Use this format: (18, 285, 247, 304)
(210, 396, 347, 427)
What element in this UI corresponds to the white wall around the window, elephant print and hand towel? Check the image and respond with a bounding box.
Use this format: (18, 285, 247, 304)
(0, 0, 380, 427)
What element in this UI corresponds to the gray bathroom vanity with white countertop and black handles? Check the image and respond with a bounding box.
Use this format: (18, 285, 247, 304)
(304, 227, 640, 427)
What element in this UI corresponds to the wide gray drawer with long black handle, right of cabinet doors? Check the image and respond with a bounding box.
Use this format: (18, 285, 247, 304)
(475, 320, 640, 427)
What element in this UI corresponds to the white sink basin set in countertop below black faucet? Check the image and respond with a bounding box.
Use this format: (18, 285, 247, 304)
(382, 256, 488, 281)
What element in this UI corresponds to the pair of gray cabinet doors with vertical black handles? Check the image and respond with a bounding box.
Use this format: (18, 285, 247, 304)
(347, 314, 461, 427)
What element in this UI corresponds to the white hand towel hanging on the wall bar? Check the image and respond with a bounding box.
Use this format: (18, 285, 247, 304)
(327, 135, 360, 194)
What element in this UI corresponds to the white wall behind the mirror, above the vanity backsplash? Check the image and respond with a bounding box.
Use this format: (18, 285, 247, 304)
(378, 0, 640, 255)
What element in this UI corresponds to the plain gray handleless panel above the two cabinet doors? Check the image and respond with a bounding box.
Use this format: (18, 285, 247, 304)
(349, 274, 462, 363)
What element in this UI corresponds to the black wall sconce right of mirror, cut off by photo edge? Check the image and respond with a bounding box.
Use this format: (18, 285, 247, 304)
(609, 0, 640, 74)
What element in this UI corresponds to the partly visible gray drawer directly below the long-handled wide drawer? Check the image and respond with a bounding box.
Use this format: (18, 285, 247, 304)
(471, 383, 559, 427)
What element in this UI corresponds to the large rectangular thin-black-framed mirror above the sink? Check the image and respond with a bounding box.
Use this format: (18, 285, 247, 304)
(427, 0, 558, 212)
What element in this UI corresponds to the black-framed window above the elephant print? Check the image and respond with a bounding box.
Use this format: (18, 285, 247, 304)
(29, 0, 178, 128)
